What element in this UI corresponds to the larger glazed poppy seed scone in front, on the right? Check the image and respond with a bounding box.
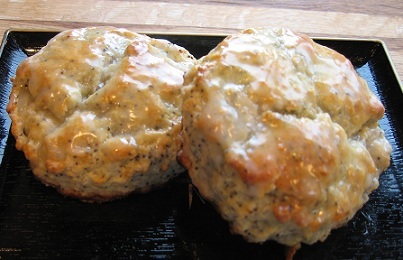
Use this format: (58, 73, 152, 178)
(179, 28, 391, 246)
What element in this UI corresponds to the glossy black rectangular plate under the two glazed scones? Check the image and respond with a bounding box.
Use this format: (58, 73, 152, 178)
(0, 31, 403, 259)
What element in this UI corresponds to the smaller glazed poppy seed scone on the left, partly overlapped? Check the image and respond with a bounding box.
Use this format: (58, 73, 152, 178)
(7, 27, 195, 202)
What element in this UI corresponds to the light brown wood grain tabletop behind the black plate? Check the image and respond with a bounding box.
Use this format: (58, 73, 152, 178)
(0, 0, 403, 82)
